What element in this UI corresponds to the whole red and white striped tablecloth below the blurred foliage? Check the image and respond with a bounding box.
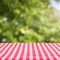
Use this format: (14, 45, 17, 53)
(0, 43, 60, 60)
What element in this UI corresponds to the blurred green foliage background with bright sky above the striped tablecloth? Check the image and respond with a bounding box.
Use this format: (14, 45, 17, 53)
(0, 0, 60, 42)
